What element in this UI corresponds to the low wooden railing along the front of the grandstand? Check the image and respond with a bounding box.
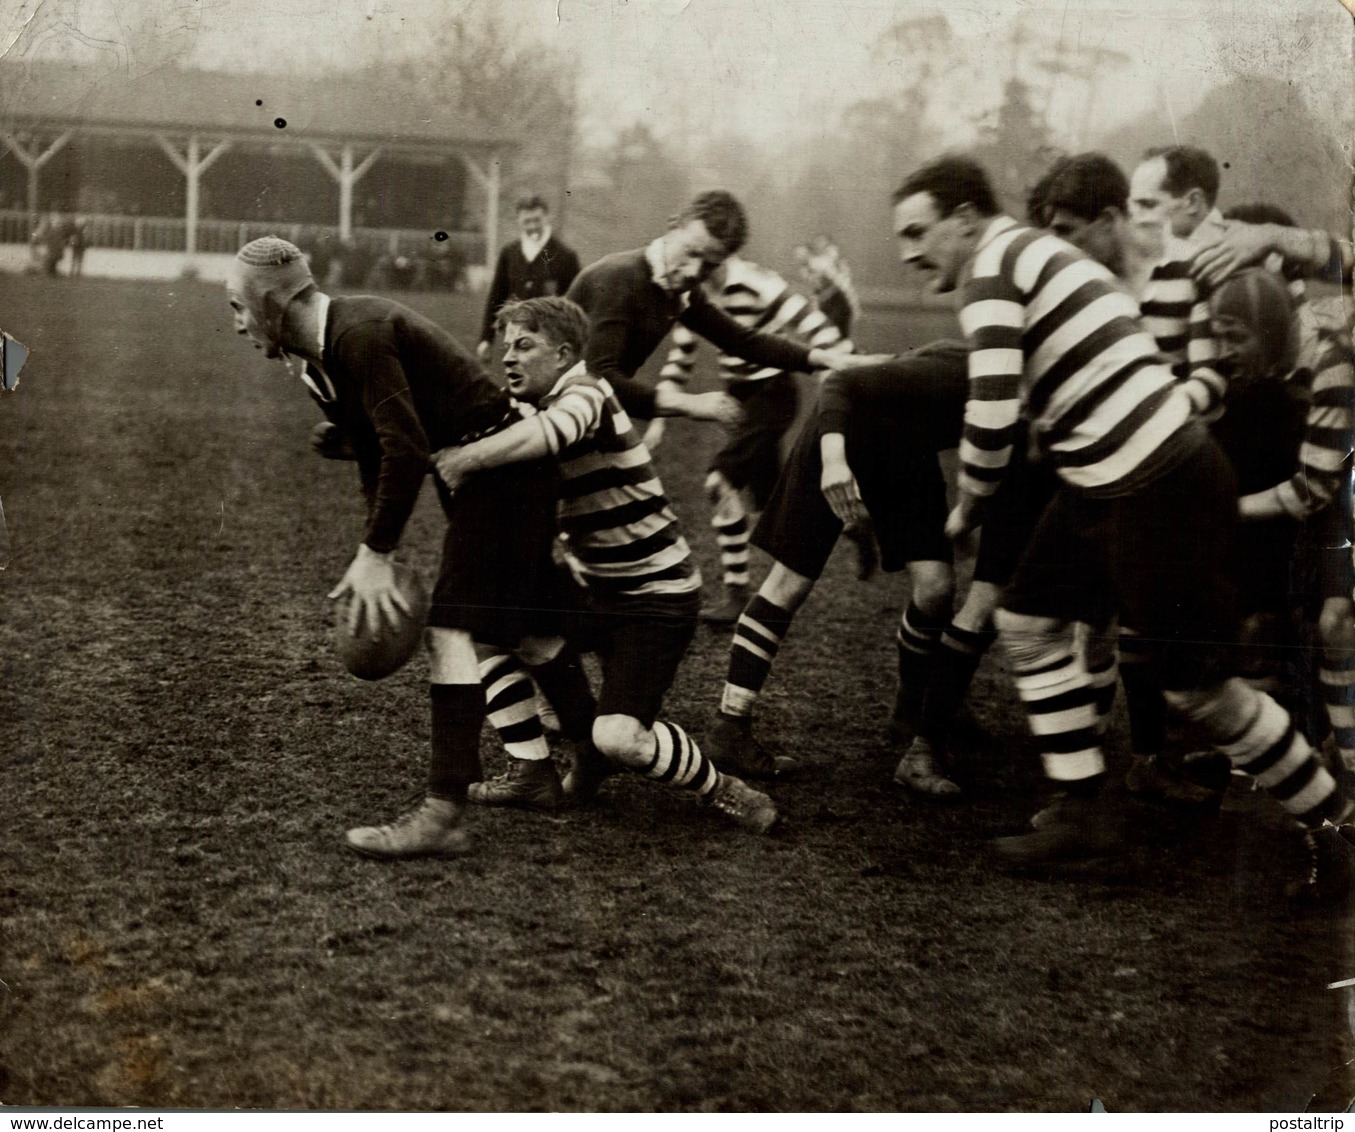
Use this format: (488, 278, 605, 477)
(0, 209, 485, 263)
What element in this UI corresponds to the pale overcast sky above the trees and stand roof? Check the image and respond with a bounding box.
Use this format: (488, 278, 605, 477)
(0, 0, 1355, 153)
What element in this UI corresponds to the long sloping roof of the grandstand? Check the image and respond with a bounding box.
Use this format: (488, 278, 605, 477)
(0, 61, 514, 152)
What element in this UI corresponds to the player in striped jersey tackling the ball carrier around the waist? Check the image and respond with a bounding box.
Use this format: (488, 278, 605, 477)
(435, 297, 776, 832)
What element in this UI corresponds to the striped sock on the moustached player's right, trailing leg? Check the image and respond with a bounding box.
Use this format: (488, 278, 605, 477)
(1167, 676, 1350, 830)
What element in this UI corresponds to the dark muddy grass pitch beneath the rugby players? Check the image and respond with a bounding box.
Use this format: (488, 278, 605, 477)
(0, 277, 1355, 1110)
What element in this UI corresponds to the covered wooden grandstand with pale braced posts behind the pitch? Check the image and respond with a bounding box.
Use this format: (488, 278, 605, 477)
(0, 62, 515, 274)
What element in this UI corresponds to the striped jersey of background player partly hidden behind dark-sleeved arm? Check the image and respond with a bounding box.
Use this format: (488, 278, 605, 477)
(659, 256, 852, 385)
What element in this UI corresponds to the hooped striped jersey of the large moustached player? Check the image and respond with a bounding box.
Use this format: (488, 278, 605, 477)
(959, 216, 1191, 496)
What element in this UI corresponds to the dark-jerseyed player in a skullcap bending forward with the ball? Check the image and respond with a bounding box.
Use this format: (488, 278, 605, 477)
(226, 236, 557, 857)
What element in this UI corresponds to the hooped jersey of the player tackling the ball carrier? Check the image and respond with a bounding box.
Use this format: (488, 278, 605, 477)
(533, 362, 701, 597)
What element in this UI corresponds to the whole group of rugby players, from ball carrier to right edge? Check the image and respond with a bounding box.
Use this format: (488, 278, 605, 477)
(228, 146, 1355, 903)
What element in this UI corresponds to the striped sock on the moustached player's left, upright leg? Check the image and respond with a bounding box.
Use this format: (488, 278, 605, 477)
(1008, 639, 1106, 786)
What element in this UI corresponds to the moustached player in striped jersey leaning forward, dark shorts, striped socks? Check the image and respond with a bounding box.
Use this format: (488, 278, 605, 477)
(894, 157, 1351, 894)
